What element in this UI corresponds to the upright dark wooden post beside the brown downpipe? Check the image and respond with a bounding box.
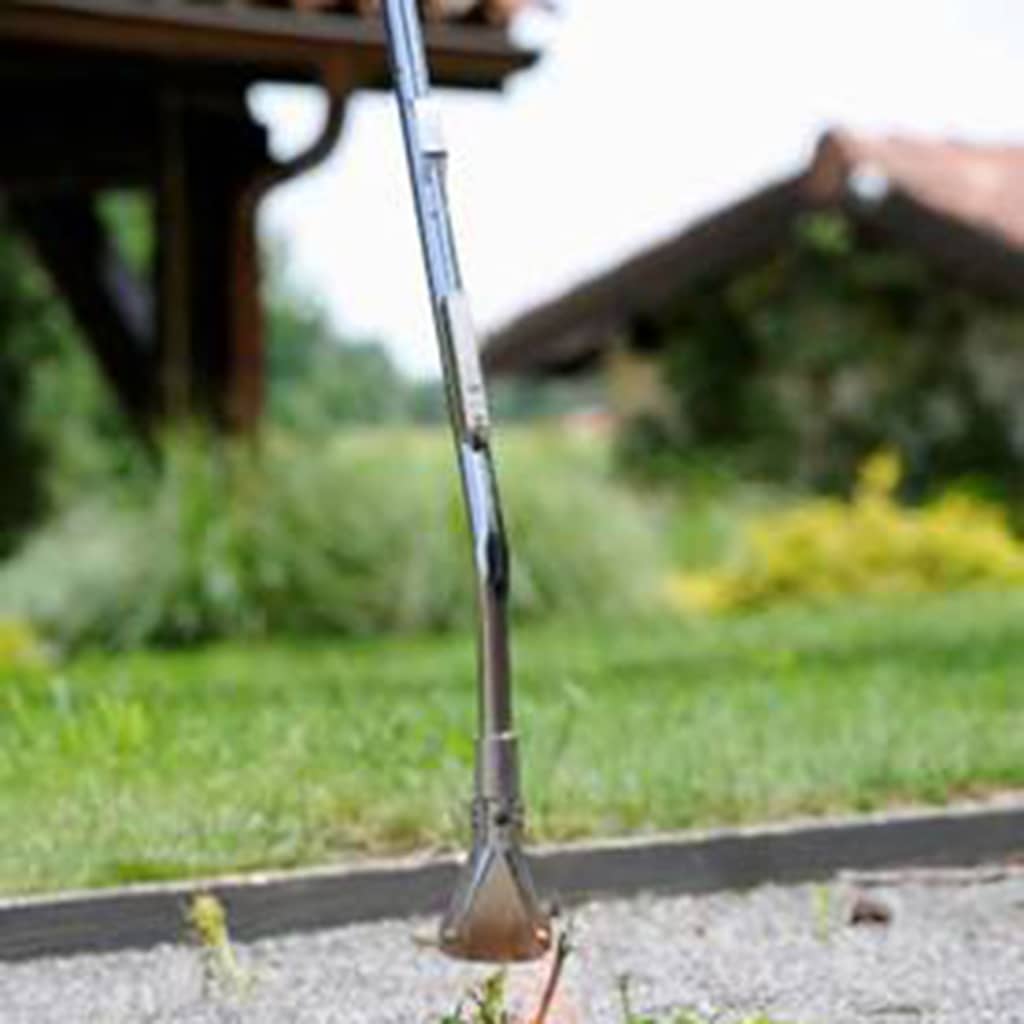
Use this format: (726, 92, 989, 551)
(157, 93, 270, 431)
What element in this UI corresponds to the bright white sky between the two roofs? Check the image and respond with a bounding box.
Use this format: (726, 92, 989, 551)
(249, 0, 1024, 374)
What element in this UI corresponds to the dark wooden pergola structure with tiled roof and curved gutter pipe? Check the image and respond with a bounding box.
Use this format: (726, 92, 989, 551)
(0, 0, 535, 430)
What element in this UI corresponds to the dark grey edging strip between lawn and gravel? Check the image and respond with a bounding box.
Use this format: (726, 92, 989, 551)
(0, 801, 1024, 961)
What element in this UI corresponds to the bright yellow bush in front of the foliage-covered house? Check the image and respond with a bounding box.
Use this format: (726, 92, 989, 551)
(670, 453, 1024, 611)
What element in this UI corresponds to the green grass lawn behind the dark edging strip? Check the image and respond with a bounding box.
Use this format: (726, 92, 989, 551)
(0, 593, 1024, 892)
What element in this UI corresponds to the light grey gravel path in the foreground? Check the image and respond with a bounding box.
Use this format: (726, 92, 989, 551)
(0, 869, 1024, 1024)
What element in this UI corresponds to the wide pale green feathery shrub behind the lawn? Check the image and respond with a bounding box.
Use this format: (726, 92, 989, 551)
(0, 431, 663, 647)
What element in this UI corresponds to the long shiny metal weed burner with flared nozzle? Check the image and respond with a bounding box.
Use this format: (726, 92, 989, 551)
(384, 0, 551, 962)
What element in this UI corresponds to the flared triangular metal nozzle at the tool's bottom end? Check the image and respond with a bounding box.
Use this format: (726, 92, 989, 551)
(441, 840, 551, 963)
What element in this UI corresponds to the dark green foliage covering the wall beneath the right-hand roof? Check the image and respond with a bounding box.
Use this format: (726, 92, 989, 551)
(643, 213, 1024, 494)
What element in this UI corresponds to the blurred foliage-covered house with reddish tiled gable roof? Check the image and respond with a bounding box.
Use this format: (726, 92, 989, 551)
(484, 131, 1024, 483)
